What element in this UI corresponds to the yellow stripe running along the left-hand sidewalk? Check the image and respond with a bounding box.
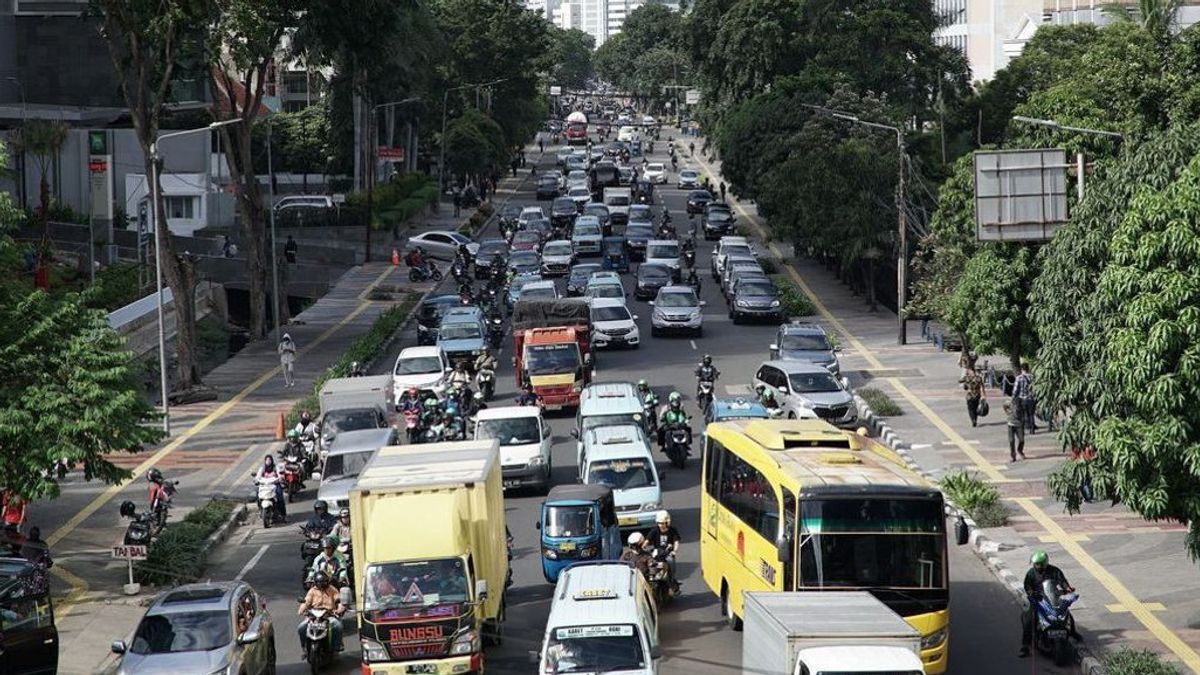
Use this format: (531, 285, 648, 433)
(46, 267, 394, 614)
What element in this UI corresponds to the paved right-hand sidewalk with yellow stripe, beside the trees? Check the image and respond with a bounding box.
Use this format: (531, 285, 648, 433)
(676, 131, 1200, 673)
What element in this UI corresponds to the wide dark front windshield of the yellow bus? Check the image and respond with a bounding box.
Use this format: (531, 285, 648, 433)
(799, 497, 946, 589)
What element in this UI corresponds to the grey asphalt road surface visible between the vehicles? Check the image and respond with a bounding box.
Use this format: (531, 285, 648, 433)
(201, 127, 1075, 675)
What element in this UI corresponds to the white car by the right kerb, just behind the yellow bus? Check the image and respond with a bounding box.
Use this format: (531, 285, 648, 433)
(754, 360, 858, 426)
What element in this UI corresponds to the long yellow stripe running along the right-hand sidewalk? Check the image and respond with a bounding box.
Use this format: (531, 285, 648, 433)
(700, 145, 1200, 673)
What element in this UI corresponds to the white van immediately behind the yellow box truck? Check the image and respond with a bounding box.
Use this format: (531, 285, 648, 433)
(475, 406, 553, 495)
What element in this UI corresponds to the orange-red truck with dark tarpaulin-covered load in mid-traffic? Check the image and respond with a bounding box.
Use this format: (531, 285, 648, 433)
(512, 299, 593, 410)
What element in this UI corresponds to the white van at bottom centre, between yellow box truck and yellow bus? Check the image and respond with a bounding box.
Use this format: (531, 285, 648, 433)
(538, 561, 662, 675)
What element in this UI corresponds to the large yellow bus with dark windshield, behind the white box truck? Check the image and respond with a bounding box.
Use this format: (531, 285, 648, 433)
(700, 420, 950, 674)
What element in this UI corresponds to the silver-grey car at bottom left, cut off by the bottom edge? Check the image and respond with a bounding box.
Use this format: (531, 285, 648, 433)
(112, 581, 274, 675)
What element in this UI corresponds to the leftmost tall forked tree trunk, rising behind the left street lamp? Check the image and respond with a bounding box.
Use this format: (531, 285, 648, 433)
(92, 0, 211, 389)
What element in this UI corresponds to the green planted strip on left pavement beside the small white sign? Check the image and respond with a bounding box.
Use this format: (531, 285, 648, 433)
(133, 500, 236, 586)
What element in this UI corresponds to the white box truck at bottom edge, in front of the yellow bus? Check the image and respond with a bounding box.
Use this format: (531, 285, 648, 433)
(742, 591, 924, 675)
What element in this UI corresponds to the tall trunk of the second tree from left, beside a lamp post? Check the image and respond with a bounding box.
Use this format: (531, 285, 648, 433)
(205, 0, 304, 339)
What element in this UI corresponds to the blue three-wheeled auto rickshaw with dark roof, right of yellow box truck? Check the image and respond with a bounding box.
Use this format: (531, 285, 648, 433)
(538, 485, 620, 584)
